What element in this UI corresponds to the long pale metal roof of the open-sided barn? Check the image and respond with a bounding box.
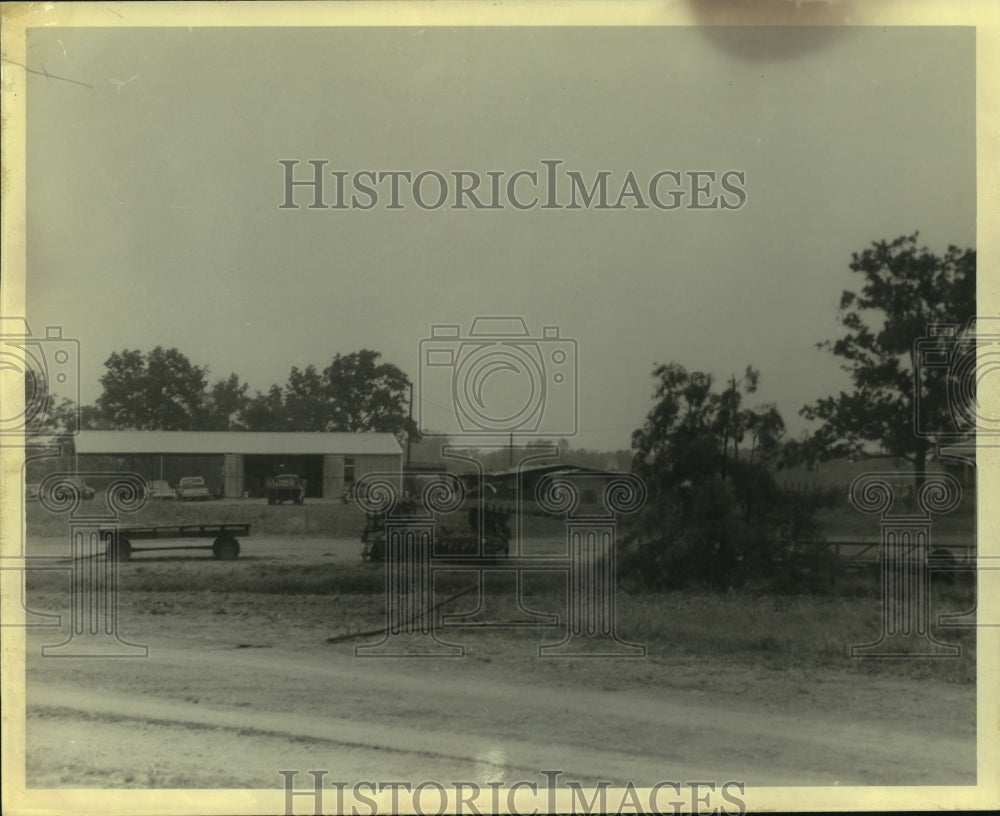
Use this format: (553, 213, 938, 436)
(74, 431, 403, 456)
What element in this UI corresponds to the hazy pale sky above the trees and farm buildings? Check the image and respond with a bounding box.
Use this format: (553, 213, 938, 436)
(27, 27, 976, 450)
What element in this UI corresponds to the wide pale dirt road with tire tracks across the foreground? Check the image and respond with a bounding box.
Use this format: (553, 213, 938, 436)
(27, 616, 975, 788)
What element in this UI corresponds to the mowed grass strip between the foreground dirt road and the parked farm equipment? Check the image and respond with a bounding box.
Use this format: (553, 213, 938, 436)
(26, 558, 976, 683)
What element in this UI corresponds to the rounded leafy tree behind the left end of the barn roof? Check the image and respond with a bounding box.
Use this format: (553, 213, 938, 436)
(97, 346, 207, 431)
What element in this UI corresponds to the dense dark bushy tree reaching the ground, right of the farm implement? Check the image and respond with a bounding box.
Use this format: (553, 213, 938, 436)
(620, 363, 809, 587)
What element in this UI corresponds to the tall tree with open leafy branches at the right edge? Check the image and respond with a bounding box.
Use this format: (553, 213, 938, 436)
(801, 233, 976, 480)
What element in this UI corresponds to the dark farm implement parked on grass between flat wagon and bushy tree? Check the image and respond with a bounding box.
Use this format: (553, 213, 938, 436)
(361, 504, 511, 561)
